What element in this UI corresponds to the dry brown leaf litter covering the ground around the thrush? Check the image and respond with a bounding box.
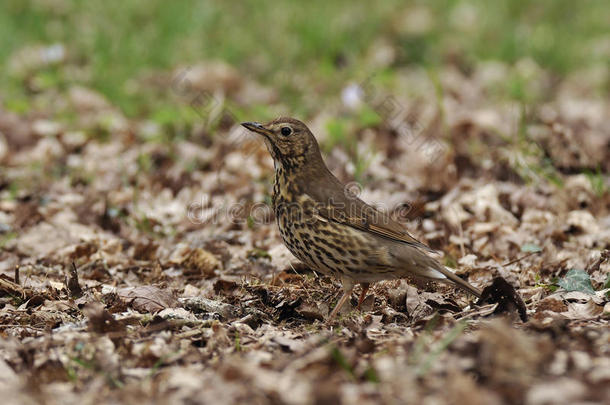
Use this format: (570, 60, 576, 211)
(0, 55, 610, 404)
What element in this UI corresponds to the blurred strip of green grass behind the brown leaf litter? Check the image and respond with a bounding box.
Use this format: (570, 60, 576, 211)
(0, 0, 610, 117)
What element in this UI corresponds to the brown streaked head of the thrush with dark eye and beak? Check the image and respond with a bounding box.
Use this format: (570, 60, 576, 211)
(241, 117, 322, 169)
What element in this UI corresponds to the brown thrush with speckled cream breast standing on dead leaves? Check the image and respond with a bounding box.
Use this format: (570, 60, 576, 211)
(241, 117, 481, 322)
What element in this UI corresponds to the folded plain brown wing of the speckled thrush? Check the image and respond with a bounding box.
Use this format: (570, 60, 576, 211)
(310, 176, 434, 252)
